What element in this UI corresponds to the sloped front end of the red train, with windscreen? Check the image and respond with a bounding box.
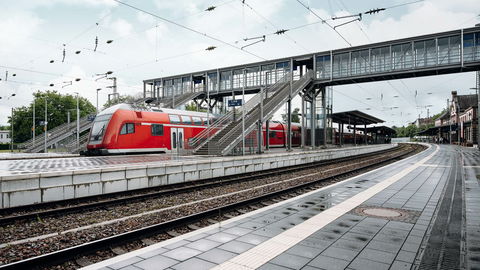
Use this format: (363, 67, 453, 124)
(85, 104, 130, 156)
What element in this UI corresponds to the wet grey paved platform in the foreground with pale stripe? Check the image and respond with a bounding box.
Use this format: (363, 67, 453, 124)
(83, 145, 480, 270)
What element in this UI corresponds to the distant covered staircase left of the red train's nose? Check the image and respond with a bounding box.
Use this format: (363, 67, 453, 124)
(19, 117, 93, 153)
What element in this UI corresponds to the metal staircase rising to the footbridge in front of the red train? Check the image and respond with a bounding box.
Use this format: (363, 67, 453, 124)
(193, 71, 313, 155)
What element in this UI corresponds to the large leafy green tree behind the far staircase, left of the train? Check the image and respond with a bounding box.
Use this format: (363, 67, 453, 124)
(8, 91, 95, 143)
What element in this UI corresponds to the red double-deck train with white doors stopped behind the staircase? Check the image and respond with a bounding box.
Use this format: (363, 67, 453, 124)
(86, 104, 301, 155)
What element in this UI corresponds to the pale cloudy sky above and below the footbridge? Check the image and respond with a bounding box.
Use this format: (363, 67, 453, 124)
(0, 0, 480, 126)
